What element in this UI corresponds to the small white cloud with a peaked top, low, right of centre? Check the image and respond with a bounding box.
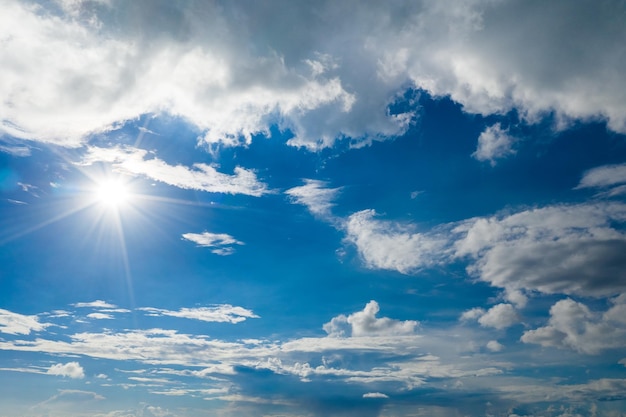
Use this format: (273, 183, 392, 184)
(323, 300, 419, 337)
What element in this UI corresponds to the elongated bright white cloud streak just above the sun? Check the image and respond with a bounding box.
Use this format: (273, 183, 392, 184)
(81, 147, 270, 197)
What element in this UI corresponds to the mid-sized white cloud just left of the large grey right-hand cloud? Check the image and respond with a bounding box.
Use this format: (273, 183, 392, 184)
(345, 210, 447, 274)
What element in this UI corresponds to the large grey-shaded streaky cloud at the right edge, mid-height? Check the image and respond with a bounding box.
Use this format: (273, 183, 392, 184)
(453, 202, 626, 296)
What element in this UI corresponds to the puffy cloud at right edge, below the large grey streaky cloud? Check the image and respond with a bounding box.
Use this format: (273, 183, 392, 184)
(522, 294, 626, 354)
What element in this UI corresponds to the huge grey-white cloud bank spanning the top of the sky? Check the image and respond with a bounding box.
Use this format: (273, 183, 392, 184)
(0, 0, 626, 149)
